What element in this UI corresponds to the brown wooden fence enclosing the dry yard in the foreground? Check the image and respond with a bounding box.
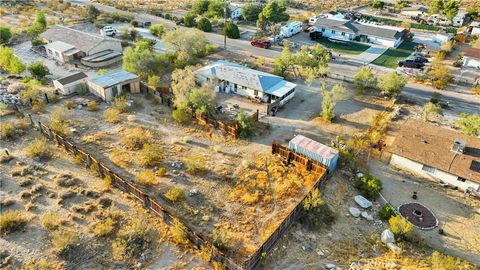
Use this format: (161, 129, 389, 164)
(17, 108, 328, 270)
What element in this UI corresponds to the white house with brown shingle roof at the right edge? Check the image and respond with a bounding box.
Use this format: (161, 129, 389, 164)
(390, 119, 480, 191)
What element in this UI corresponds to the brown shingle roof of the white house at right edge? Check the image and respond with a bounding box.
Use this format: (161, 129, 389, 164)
(392, 118, 480, 183)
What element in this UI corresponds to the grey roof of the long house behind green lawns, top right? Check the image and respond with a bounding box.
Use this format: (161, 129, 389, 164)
(315, 18, 404, 39)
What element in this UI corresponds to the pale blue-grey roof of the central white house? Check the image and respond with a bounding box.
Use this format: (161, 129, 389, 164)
(197, 60, 297, 97)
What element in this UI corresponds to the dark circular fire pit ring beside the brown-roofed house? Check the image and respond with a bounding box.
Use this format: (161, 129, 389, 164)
(398, 203, 438, 230)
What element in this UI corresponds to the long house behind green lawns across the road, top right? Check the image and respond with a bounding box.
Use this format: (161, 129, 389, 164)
(313, 17, 407, 48)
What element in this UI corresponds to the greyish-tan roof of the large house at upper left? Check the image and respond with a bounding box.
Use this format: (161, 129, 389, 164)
(40, 25, 116, 52)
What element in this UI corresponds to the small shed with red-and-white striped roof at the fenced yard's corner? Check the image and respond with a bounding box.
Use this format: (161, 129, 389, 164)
(288, 135, 339, 174)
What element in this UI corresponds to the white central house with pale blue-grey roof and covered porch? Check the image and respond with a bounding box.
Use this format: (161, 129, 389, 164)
(196, 60, 297, 106)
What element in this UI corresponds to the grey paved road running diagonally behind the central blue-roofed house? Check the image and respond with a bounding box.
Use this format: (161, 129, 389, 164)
(69, 0, 480, 114)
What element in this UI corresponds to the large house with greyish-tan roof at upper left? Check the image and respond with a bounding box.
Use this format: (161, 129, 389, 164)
(40, 25, 122, 67)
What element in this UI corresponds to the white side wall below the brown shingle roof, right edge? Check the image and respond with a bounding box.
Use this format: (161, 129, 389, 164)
(390, 154, 480, 191)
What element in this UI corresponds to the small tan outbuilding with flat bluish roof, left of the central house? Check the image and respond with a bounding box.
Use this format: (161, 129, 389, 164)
(87, 69, 140, 102)
